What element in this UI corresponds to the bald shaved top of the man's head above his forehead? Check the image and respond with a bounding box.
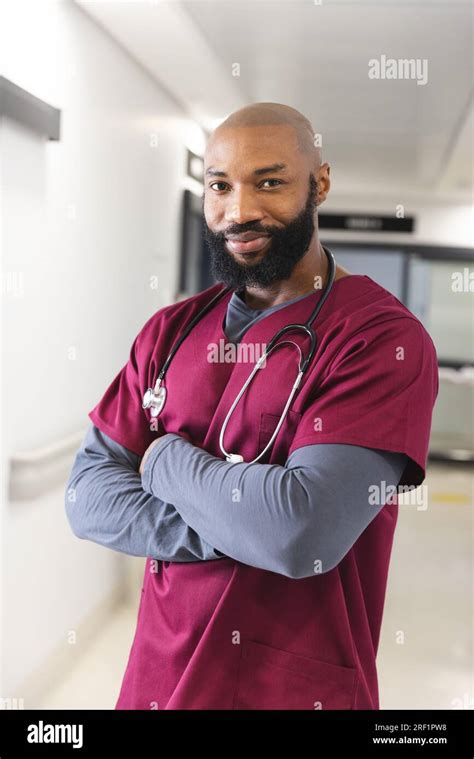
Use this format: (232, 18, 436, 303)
(208, 103, 321, 171)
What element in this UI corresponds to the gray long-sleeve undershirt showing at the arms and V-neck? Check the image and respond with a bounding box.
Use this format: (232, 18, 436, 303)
(66, 293, 407, 578)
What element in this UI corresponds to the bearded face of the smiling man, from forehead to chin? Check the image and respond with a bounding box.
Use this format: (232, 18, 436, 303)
(203, 126, 317, 291)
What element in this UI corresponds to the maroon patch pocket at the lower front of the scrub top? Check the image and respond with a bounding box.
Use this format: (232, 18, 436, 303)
(234, 640, 357, 710)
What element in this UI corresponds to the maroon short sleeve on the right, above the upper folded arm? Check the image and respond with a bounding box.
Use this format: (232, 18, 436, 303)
(289, 317, 439, 487)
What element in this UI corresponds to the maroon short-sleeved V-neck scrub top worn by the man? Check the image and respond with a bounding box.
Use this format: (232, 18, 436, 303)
(89, 275, 438, 709)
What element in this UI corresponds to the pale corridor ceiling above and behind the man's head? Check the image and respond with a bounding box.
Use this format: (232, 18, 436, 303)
(77, 0, 474, 202)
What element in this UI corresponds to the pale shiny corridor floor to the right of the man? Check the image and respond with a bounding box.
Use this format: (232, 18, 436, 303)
(378, 464, 474, 709)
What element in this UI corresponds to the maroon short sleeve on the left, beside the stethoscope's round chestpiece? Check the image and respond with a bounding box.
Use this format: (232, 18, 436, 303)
(88, 322, 156, 456)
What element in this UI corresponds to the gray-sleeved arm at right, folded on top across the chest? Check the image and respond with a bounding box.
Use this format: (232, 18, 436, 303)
(142, 434, 407, 578)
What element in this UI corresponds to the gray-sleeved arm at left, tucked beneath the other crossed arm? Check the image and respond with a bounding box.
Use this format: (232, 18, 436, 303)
(65, 425, 221, 562)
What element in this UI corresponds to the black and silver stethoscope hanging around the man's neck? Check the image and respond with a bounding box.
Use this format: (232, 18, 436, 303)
(142, 246, 336, 464)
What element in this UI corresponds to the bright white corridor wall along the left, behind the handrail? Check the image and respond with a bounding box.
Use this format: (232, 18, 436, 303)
(0, 3, 189, 708)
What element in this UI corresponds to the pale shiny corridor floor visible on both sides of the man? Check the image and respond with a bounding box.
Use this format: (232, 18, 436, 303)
(38, 465, 474, 709)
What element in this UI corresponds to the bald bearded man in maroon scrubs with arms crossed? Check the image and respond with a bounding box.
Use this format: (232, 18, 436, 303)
(66, 103, 438, 709)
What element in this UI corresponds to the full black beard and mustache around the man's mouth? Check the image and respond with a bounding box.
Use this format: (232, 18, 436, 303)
(203, 175, 318, 292)
